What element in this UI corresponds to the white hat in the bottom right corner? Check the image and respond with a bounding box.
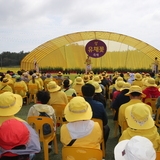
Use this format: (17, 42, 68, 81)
(114, 136, 156, 160)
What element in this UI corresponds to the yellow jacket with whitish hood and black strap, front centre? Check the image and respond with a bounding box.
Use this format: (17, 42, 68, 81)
(60, 120, 102, 149)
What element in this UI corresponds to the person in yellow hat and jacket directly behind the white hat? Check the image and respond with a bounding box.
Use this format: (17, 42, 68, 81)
(119, 103, 160, 151)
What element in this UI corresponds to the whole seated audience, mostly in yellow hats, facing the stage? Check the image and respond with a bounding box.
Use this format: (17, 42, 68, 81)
(0, 71, 160, 160)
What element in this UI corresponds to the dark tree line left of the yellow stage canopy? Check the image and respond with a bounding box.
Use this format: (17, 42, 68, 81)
(0, 51, 29, 67)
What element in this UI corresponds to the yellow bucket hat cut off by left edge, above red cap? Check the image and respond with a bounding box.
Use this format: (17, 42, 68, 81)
(0, 92, 23, 116)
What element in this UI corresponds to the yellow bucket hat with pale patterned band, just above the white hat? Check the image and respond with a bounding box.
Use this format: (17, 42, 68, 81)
(125, 103, 154, 129)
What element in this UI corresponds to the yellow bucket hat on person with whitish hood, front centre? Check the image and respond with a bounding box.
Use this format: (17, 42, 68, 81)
(64, 96, 92, 122)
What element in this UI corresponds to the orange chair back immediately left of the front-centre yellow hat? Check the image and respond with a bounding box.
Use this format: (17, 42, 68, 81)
(52, 104, 66, 124)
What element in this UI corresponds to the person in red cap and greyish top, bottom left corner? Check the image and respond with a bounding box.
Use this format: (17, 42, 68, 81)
(0, 119, 40, 160)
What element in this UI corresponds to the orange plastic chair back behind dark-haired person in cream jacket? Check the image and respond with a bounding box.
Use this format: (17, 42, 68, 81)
(28, 116, 54, 142)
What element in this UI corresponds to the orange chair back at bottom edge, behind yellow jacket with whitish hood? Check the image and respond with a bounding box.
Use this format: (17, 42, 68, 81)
(62, 147, 102, 160)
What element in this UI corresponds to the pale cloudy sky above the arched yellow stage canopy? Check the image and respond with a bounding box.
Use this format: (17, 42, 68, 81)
(0, 0, 160, 53)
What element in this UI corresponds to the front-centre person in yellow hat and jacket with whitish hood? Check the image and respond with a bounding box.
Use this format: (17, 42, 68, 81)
(60, 96, 102, 149)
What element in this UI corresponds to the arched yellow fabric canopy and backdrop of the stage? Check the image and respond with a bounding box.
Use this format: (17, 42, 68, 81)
(21, 31, 160, 70)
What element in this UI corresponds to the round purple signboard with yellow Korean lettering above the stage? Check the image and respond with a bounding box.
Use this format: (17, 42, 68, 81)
(85, 39, 107, 58)
